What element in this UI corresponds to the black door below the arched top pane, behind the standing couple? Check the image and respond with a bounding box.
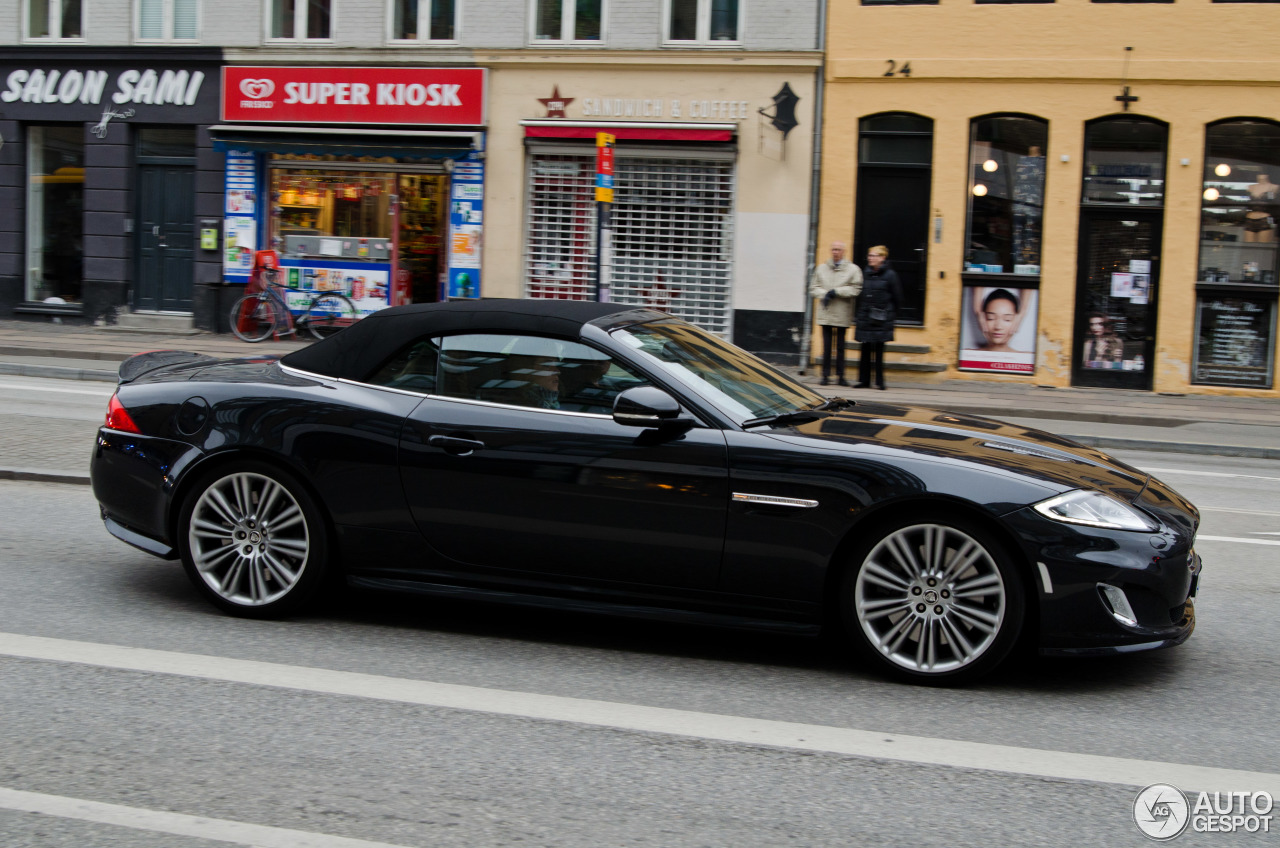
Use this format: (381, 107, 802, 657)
(854, 168, 931, 324)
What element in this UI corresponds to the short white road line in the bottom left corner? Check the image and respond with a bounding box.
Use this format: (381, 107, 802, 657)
(0, 787, 414, 848)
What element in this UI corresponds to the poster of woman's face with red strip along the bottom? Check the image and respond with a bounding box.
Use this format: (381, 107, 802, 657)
(960, 286, 1039, 374)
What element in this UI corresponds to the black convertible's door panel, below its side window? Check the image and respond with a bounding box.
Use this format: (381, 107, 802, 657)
(401, 397, 728, 588)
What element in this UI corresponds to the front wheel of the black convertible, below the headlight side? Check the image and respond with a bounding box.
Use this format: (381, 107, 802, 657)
(840, 515, 1027, 685)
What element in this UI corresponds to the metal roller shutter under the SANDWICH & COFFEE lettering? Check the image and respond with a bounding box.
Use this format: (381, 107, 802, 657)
(525, 150, 733, 337)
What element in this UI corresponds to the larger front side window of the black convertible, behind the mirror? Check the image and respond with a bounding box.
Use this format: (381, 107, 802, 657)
(436, 333, 648, 415)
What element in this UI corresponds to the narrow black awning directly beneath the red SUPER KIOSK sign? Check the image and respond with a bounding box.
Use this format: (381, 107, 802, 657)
(209, 129, 472, 161)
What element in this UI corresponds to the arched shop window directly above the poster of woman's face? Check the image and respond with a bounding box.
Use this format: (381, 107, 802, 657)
(964, 115, 1048, 277)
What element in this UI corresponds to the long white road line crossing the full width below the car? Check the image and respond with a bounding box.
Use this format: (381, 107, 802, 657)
(0, 633, 1280, 795)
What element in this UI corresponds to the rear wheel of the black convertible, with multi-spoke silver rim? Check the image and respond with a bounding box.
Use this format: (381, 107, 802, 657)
(178, 461, 329, 619)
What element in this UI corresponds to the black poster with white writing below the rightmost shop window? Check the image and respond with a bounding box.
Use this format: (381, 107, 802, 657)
(1192, 297, 1276, 388)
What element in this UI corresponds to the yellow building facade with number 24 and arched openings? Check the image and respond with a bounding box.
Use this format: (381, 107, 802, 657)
(819, 0, 1280, 396)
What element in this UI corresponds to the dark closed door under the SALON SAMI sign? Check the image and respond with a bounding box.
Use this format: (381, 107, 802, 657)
(133, 165, 196, 313)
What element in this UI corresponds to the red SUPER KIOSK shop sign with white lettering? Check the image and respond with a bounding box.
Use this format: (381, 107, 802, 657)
(223, 67, 485, 127)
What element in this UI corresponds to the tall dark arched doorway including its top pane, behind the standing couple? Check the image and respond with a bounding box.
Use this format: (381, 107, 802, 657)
(854, 113, 933, 324)
